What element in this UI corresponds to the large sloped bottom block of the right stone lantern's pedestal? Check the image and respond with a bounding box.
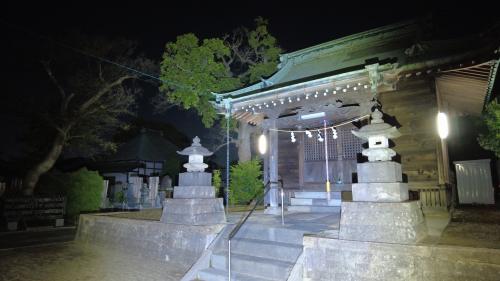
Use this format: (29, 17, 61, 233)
(339, 201, 427, 244)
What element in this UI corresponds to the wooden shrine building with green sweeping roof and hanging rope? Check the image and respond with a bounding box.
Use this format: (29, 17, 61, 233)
(216, 21, 500, 210)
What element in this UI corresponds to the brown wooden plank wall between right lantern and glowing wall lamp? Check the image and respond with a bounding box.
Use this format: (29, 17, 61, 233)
(379, 78, 439, 188)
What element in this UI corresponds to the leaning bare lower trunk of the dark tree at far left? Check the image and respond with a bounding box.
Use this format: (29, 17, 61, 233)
(23, 133, 66, 196)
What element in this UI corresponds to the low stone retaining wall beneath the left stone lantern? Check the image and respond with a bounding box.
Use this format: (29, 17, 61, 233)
(76, 214, 224, 268)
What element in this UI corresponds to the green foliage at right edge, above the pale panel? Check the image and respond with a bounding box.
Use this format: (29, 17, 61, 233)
(478, 101, 500, 157)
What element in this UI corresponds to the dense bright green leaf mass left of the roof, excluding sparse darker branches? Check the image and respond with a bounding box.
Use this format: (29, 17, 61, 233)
(160, 33, 239, 127)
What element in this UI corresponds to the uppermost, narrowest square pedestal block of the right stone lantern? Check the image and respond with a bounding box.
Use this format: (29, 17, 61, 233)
(357, 161, 403, 183)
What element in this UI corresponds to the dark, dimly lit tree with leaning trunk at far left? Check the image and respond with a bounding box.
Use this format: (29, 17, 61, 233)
(19, 37, 154, 195)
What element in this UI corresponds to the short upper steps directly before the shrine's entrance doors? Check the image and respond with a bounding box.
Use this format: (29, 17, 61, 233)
(288, 191, 342, 213)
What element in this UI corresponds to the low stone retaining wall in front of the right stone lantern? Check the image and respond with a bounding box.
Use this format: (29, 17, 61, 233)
(303, 236, 500, 281)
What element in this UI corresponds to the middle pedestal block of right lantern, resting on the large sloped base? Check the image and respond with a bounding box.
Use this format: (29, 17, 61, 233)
(352, 182, 408, 202)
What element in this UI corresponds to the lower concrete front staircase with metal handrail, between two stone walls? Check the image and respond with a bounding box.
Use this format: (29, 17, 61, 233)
(198, 220, 312, 281)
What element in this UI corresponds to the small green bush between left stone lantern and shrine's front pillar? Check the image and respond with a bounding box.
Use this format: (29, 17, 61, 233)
(229, 159, 264, 204)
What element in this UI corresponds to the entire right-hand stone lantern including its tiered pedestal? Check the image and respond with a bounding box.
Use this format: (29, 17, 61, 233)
(339, 109, 427, 244)
